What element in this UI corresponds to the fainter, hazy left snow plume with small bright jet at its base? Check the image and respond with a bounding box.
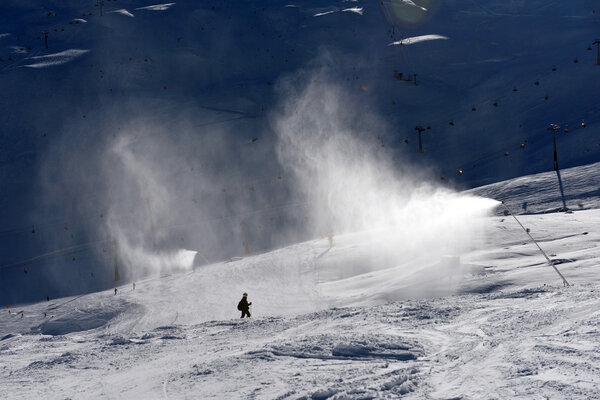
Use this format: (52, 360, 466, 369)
(36, 102, 270, 297)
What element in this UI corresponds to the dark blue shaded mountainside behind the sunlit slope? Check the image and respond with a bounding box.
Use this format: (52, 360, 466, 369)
(0, 0, 600, 303)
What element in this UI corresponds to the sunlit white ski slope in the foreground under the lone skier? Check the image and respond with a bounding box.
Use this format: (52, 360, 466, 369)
(0, 164, 600, 399)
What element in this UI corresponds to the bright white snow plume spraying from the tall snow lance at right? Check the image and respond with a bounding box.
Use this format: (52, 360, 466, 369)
(273, 67, 497, 292)
